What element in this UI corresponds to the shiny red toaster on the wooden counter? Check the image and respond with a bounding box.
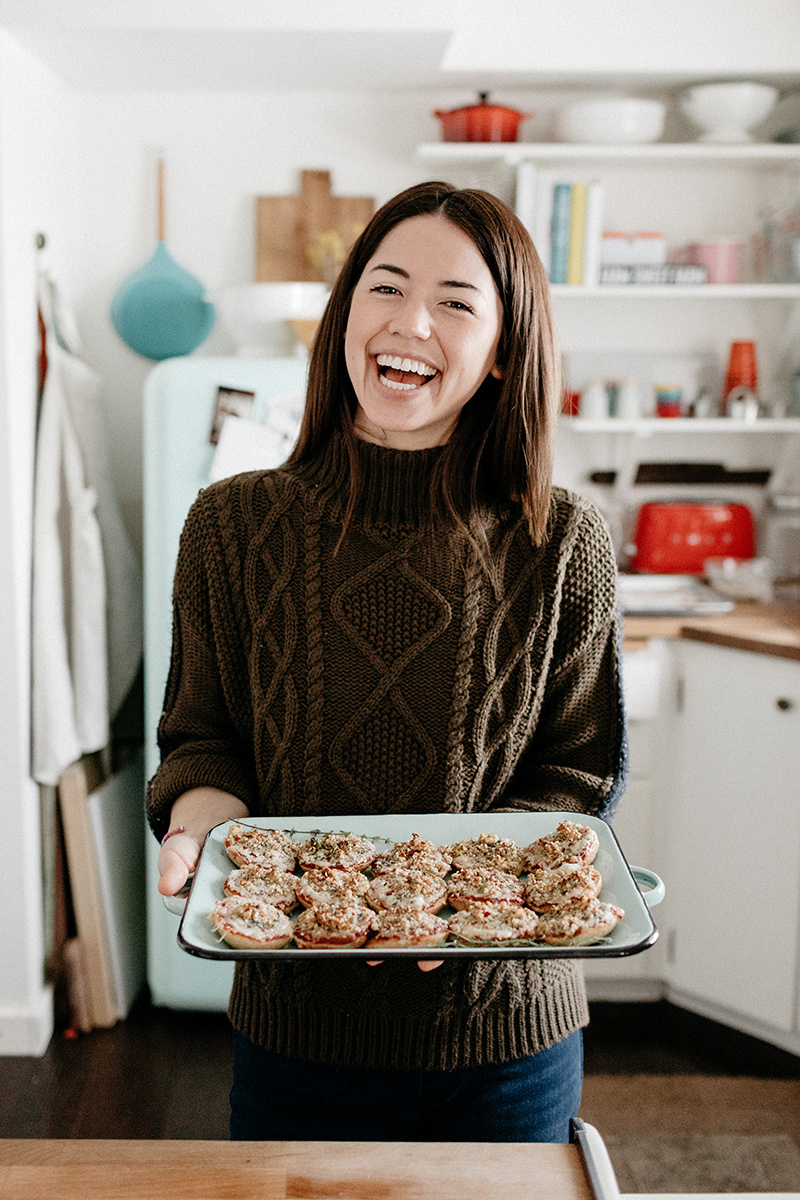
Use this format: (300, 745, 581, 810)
(631, 500, 756, 575)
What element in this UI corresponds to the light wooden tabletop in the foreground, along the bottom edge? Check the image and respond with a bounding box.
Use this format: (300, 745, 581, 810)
(0, 1139, 591, 1200)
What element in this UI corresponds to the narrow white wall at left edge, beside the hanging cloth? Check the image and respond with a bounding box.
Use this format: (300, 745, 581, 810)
(0, 31, 66, 1054)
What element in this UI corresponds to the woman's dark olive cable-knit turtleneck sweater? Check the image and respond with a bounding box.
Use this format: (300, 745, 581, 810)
(148, 439, 626, 1068)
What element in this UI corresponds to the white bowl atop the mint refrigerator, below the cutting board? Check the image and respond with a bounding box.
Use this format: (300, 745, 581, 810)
(217, 281, 330, 358)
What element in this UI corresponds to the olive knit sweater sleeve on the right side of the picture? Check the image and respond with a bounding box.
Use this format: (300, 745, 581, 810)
(493, 504, 627, 820)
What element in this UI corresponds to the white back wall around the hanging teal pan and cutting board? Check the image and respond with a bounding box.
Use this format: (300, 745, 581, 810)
(61, 91, 482, 552)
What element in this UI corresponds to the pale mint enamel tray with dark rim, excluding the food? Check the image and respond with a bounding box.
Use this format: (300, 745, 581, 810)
(167, 811, 664, 960)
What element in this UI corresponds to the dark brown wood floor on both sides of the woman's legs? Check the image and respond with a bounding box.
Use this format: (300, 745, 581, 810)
(0, 997, 800, 1139)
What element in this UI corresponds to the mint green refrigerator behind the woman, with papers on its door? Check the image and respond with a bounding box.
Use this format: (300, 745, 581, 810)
(144, 356, 307, 1012)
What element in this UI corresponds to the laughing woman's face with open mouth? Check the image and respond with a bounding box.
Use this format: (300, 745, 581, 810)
(344, 216, 503, 450)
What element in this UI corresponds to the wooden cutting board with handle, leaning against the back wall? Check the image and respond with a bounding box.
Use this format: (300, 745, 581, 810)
(255, 170, 375, 283)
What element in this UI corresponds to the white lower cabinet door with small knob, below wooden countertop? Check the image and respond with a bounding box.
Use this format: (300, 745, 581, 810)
(666, 642, 800, 1030)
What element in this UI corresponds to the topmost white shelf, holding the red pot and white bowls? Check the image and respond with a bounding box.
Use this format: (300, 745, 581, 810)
(416, 142, 800, 167)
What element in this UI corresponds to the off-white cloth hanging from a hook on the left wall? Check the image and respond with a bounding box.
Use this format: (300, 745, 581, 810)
(31, 329, 109, 784)
